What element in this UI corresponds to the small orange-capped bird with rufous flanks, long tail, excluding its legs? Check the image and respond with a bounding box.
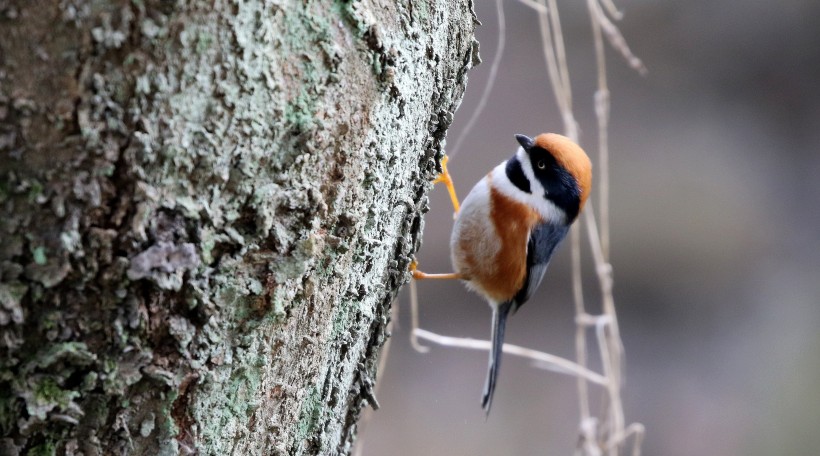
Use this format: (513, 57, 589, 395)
(450, 133, 592, 414)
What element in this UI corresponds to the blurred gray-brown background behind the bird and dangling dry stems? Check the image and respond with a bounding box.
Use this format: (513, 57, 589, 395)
(362, 0, 820, 456)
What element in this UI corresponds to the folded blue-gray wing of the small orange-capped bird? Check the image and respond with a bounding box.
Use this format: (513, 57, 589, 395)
(512, 223, 569, 312)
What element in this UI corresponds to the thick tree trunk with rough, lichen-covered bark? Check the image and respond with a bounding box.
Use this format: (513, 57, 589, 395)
(0, 0, 478, 455)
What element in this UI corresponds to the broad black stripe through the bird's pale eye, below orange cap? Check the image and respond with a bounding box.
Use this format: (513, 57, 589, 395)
(529, 147, 581, 222)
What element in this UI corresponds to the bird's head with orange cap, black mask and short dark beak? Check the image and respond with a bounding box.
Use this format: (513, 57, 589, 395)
(508, 133, 592, 222)
